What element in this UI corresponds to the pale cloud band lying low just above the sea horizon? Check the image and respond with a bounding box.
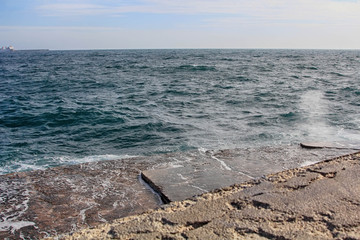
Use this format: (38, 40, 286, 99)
(0, 25, 360, 50)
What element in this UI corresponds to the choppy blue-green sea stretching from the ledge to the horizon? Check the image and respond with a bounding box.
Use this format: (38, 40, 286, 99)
(0, 49, 360, 174)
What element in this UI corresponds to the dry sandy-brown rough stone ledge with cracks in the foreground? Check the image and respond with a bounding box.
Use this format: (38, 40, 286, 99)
(60, 153, 360, 240)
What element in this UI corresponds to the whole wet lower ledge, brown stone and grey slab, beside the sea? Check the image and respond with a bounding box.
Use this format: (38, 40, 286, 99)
(0, 143, 358, 239)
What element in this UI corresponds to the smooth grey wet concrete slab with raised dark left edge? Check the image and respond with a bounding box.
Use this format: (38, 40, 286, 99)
(142, 145, 356, 202)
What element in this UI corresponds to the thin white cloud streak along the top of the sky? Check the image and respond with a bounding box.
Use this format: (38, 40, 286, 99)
(38, 0, 360, 27)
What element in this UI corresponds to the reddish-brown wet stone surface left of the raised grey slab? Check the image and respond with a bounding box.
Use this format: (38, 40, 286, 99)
(0, 158, 165, 239)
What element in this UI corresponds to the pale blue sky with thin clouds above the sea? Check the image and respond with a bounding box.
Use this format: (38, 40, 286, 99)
(0, 0, 360, 50)
